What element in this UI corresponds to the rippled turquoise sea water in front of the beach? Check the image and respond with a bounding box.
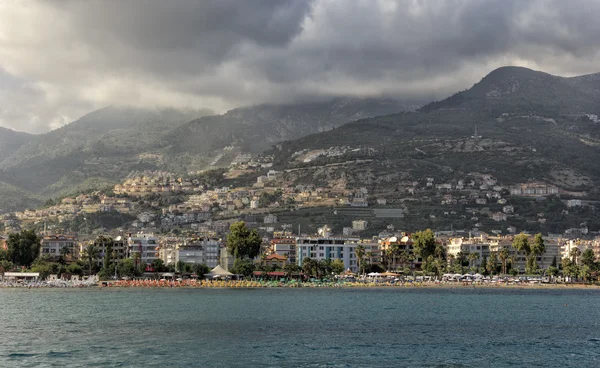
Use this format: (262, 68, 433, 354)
(0, 288, 600, 367)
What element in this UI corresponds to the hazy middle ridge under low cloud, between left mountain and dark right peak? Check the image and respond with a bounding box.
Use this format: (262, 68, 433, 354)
(166, 98, 419, 153)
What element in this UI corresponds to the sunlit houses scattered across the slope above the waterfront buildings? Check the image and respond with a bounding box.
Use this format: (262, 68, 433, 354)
(0, 147, 597, 238)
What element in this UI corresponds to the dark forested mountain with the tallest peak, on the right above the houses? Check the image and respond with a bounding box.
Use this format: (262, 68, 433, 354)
(270, 67, 600, 193)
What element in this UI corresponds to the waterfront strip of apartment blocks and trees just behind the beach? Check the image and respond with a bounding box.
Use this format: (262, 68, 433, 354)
(0, 218, 600, 281)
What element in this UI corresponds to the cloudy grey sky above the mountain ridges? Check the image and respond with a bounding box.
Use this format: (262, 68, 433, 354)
(0, 0, 600, 133)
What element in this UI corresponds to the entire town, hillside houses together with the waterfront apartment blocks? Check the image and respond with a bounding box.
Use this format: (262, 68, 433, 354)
(1, 151, 600, 284)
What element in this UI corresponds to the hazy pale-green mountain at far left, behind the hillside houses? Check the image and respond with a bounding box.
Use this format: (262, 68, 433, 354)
(0, 106, 209, 197)
